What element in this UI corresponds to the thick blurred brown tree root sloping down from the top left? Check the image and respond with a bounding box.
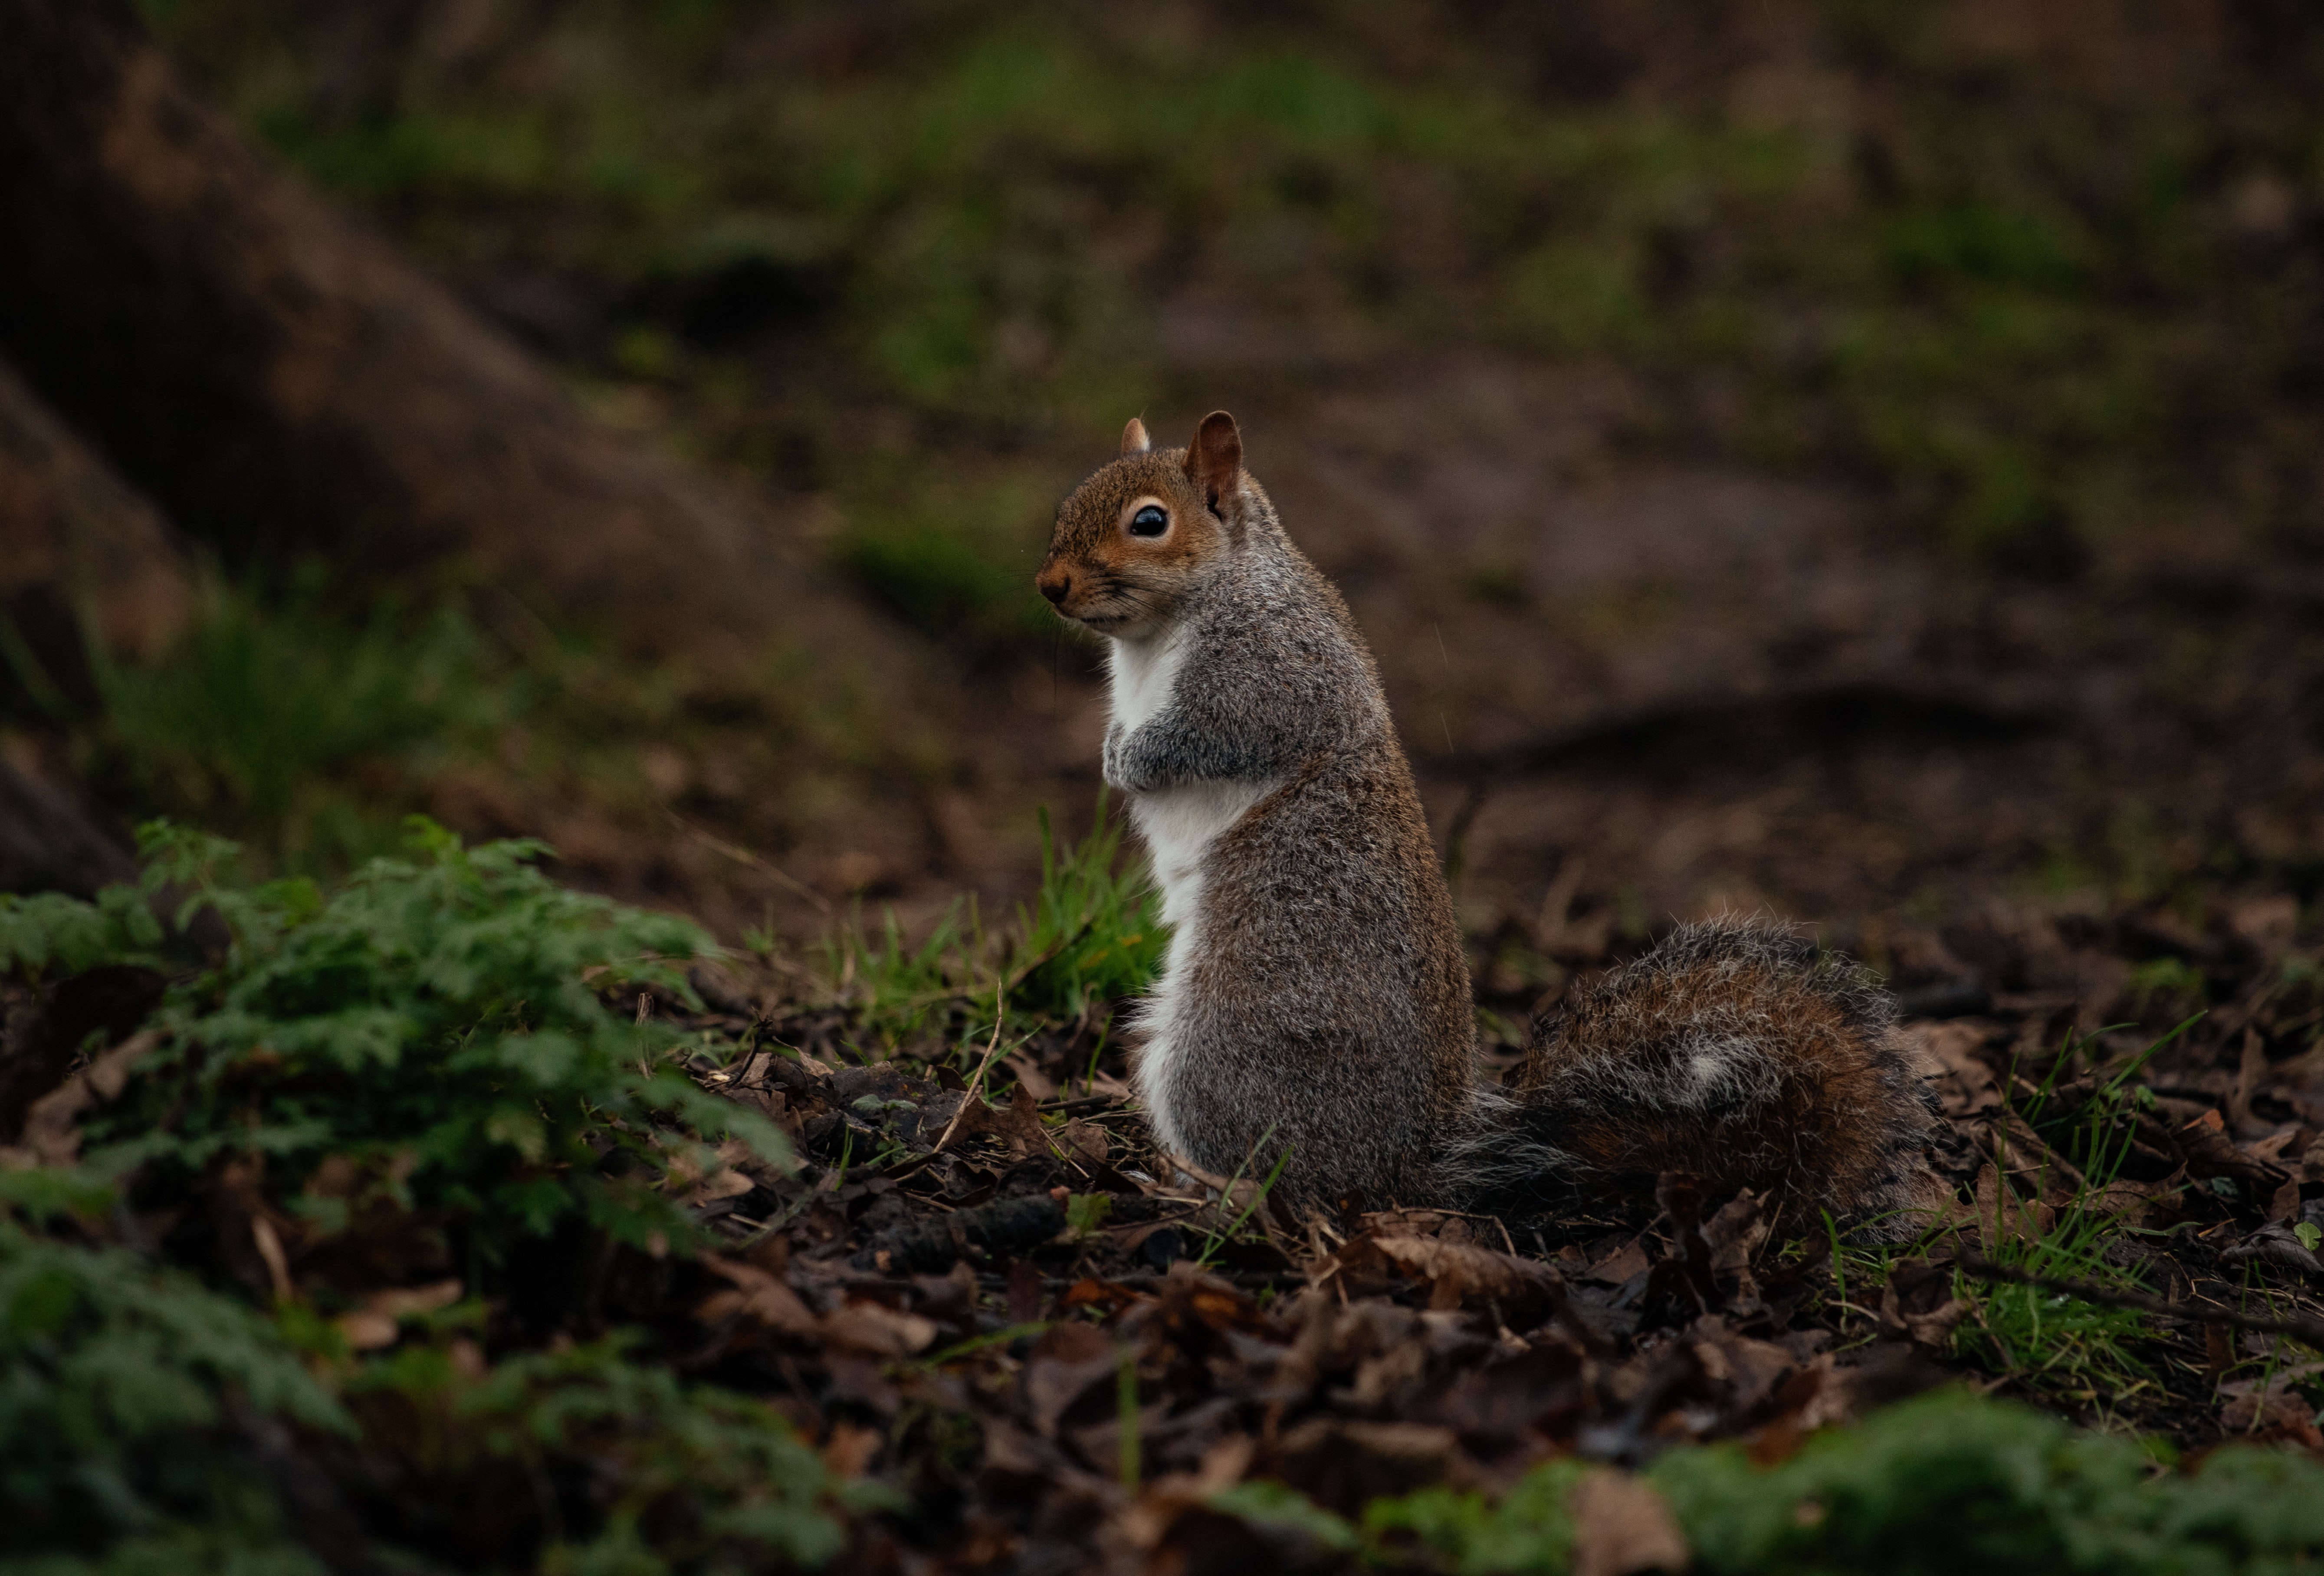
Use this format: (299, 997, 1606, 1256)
(0, 0, 855, 653)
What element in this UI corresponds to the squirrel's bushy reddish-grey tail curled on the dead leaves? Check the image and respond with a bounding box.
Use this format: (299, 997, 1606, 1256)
(1448, 918, 1940, 1237)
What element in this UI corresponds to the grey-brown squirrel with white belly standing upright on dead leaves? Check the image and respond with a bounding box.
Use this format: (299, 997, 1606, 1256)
(1034, 411, 1938, 1234)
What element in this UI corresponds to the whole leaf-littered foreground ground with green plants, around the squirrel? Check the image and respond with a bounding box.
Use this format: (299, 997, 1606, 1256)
(18, 813, 2324, 1574)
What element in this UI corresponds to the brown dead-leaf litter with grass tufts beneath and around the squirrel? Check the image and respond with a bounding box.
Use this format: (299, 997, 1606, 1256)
(650, 860, 2324, 1569)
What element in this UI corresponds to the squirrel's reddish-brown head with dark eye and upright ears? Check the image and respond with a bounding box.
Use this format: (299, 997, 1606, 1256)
(1034, 411, 1248, 637)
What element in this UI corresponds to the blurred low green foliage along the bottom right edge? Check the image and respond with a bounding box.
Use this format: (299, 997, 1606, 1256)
(1208, 1390, 2324, 1576)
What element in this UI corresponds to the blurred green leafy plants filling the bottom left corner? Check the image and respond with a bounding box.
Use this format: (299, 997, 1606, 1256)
(0, 1220, 873, 1576)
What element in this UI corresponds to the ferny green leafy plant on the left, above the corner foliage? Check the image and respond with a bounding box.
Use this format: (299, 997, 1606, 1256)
(13, 823, 788, 1265)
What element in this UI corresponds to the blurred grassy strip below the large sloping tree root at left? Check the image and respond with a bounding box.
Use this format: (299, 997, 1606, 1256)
(0, 572, 911, 902)
